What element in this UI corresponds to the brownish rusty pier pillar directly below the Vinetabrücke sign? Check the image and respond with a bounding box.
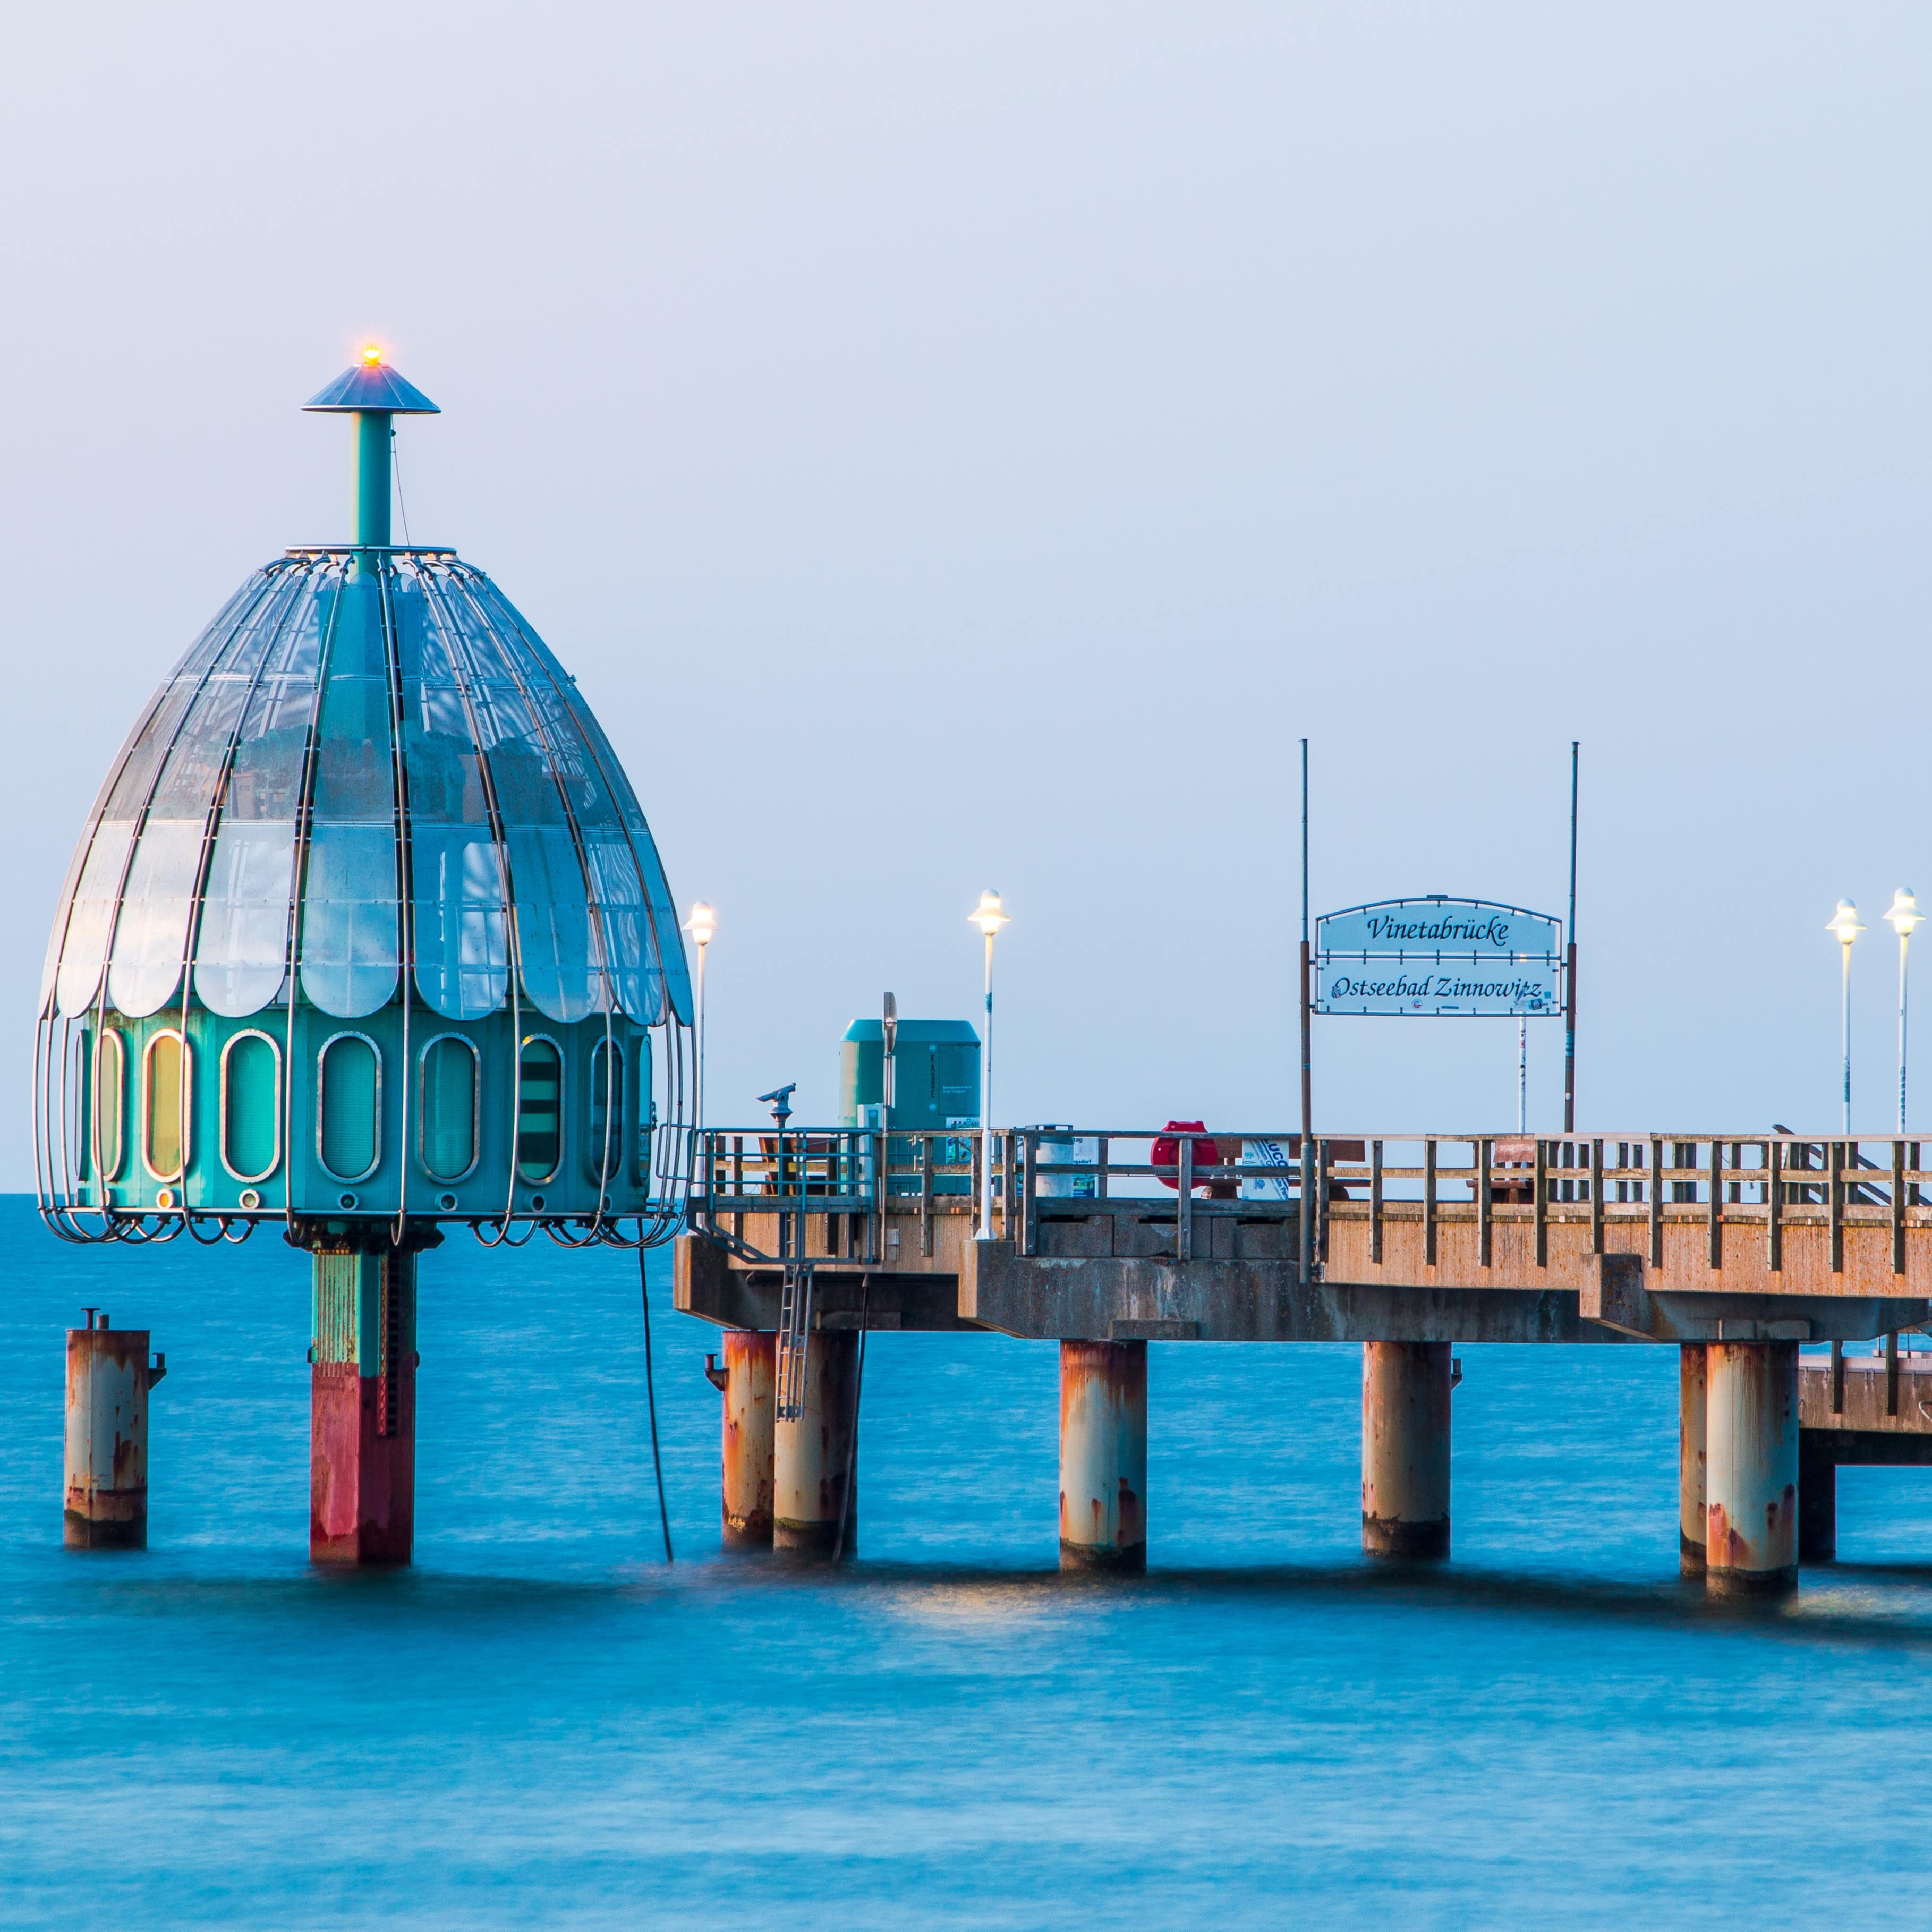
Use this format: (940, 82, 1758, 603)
(1362, 1341, 1451, 1557)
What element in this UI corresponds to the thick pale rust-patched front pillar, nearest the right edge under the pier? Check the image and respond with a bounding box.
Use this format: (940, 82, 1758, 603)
(1704, 1341, 1799, 1596)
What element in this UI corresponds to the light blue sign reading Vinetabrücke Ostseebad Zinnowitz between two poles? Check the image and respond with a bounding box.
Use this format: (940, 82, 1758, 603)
(1314, 897, 1563, 1018)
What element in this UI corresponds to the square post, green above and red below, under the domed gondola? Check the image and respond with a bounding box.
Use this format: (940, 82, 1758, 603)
(309, 1252, 415, 1563)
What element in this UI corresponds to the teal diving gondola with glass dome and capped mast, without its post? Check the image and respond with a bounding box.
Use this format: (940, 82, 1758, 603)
(35, 363, 692, 1244)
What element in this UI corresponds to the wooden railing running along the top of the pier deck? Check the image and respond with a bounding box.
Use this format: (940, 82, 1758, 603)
(692, 1126, 1932, 1275)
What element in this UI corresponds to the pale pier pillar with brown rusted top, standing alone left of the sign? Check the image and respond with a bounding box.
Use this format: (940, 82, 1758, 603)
(1061, 1341, 1147, 1571)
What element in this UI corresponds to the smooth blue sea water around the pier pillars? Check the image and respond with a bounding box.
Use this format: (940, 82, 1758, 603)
(0, 1198, 1932, 1932)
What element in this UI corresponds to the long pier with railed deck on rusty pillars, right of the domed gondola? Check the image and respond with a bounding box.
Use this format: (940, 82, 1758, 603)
(674, 1126, 1932, 1594)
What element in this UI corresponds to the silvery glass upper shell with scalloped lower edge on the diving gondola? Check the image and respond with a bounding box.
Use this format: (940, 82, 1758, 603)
(40, 551, 692, 1026)
